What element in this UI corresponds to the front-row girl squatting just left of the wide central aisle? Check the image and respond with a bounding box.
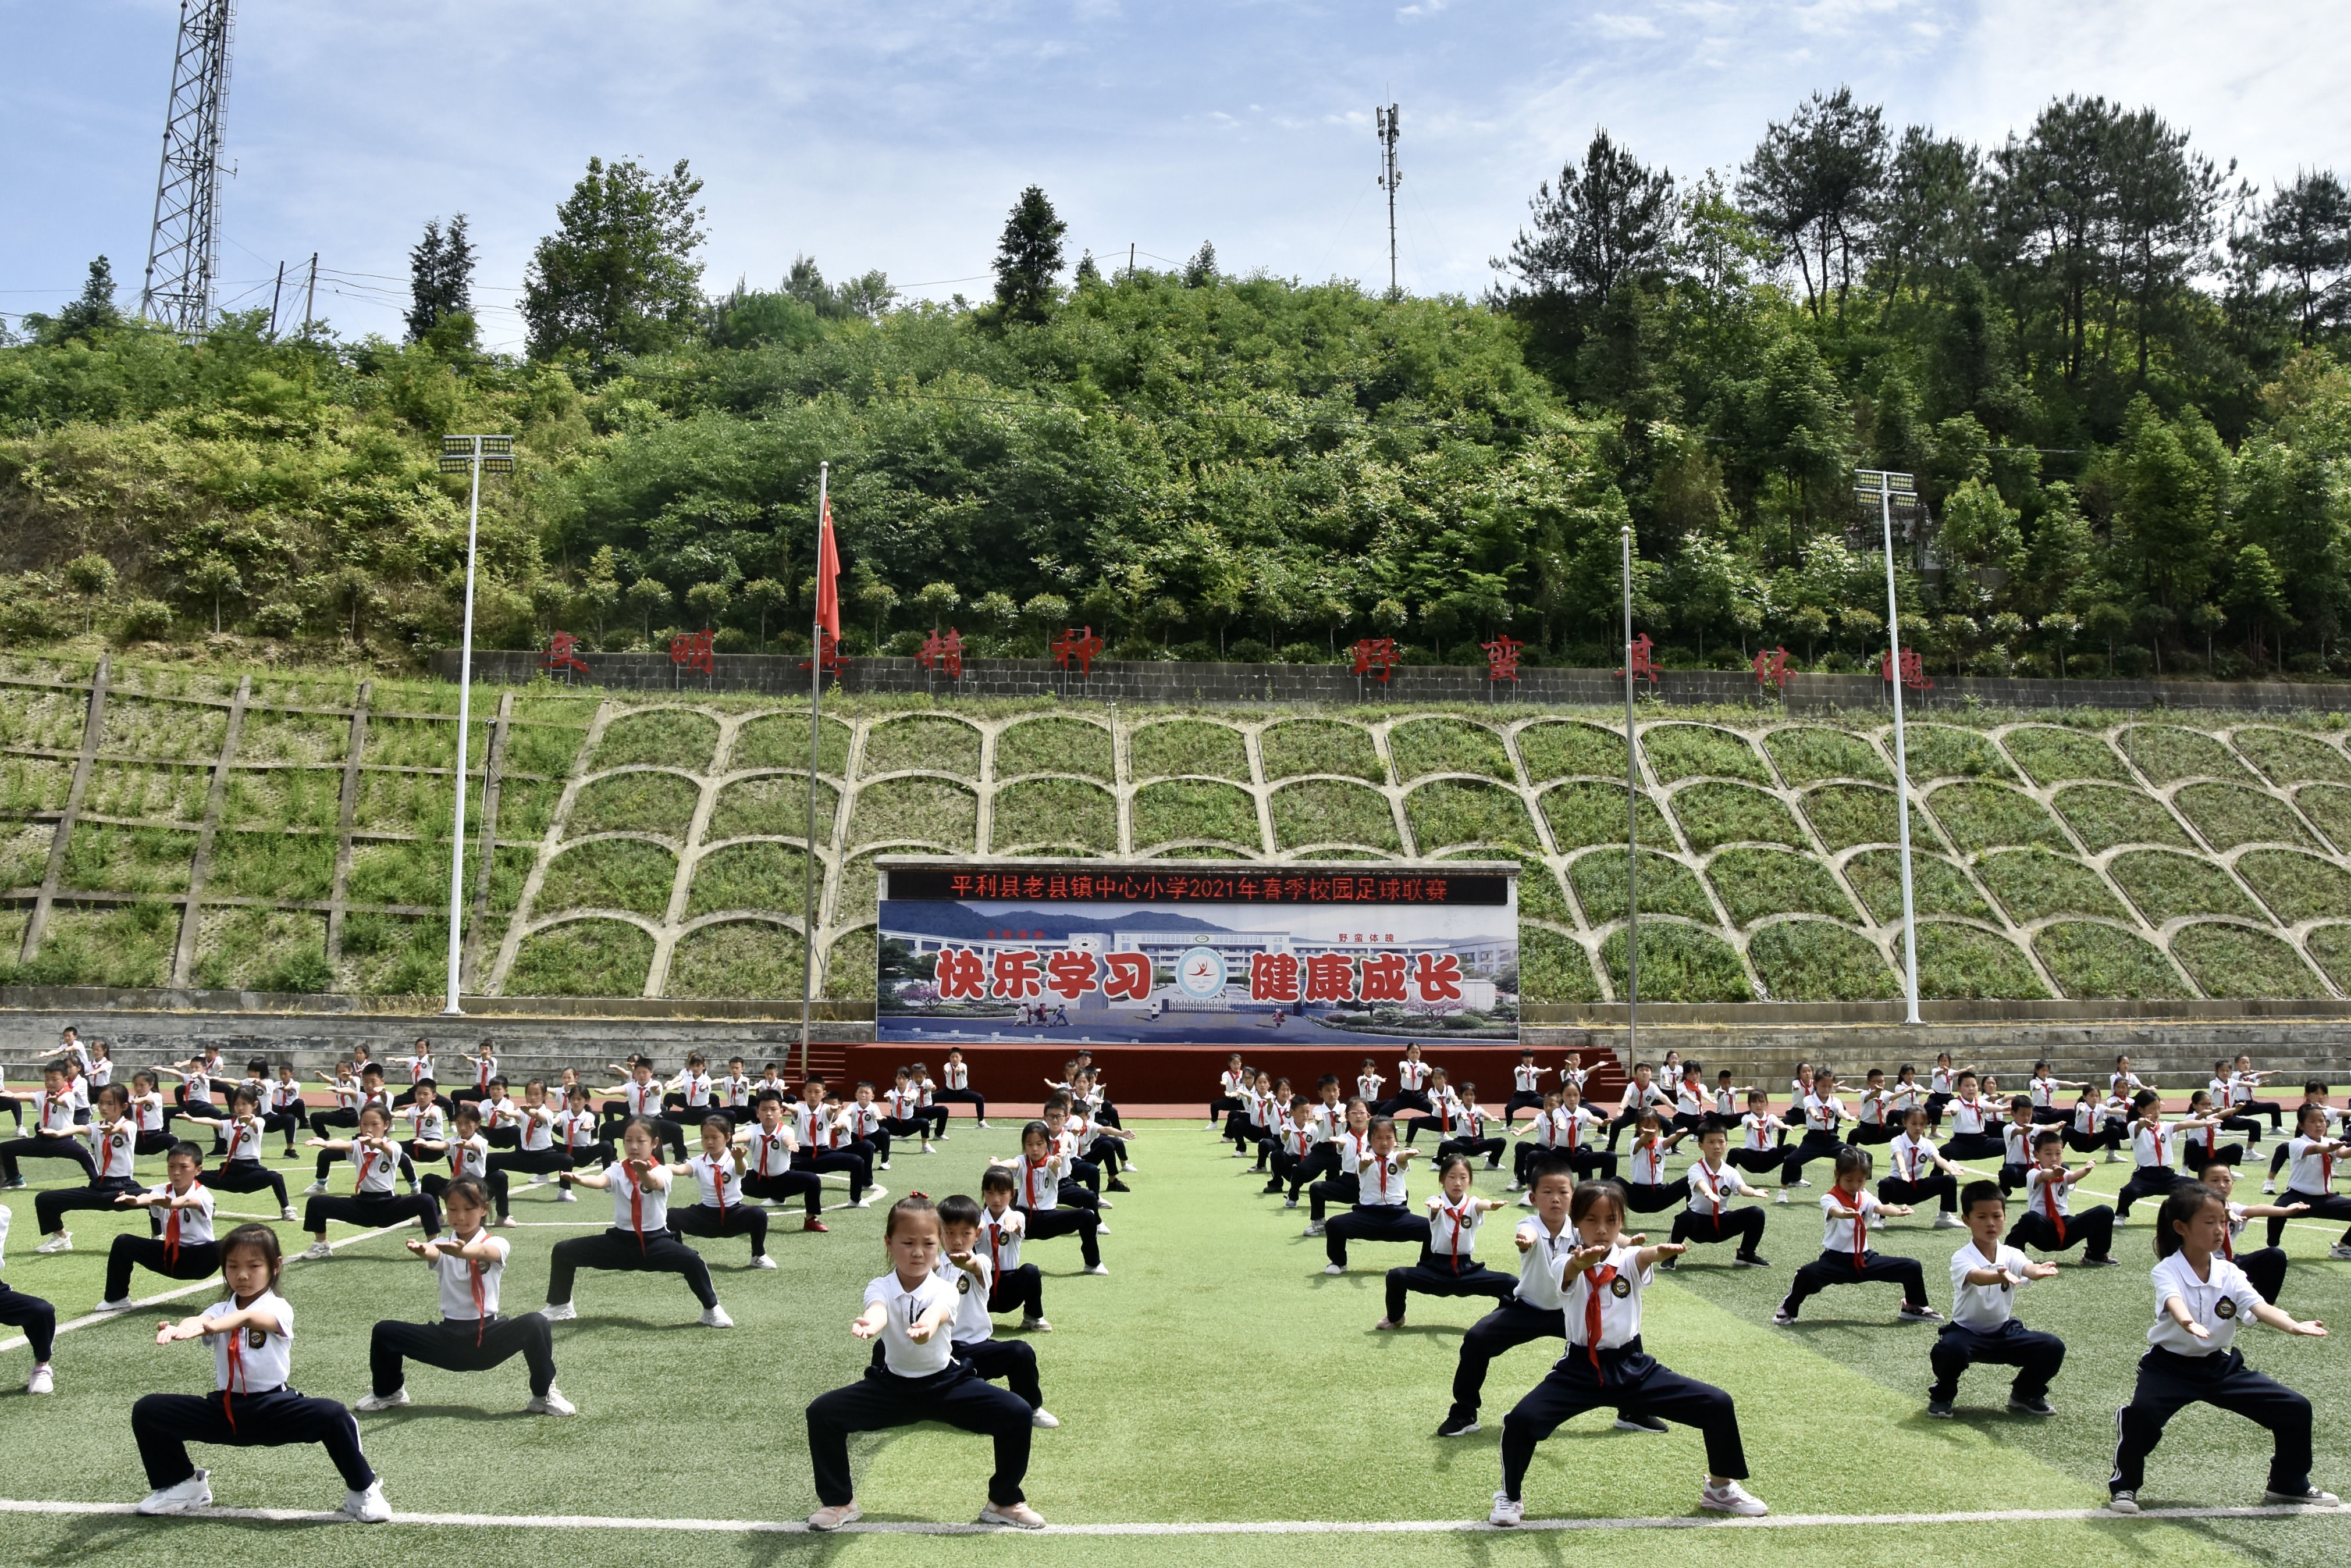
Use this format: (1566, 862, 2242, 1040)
(809, 1194, 1044, 1530)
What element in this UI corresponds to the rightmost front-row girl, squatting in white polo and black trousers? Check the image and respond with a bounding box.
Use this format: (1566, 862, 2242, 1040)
(2107, 1182, 2337, 1514)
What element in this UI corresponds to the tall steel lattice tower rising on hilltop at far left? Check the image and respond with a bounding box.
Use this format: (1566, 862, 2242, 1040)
(138, 0, 235, 338)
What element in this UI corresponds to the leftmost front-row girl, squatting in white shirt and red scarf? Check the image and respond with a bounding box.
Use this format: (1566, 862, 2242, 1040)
(131, 1225, 393, 1523)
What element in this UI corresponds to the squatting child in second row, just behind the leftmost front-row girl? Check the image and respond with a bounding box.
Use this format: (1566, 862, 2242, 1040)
(360, 1175, 578, 1415)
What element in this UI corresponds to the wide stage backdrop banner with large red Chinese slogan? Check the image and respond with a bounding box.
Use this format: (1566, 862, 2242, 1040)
(874, 856, 1518, 1046)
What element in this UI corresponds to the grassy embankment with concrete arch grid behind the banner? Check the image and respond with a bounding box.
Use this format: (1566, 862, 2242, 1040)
(0, 661, 2351, 1002)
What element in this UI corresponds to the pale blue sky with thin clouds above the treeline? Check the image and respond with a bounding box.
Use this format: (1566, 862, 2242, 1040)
(0, 0, 2351, 343)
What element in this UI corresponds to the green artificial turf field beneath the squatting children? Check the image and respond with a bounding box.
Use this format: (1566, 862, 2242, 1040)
(0, 1124, 2351, 1568)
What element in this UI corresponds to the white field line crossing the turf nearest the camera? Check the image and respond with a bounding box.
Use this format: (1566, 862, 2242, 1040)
(0, 1500, 2337, 1535)
